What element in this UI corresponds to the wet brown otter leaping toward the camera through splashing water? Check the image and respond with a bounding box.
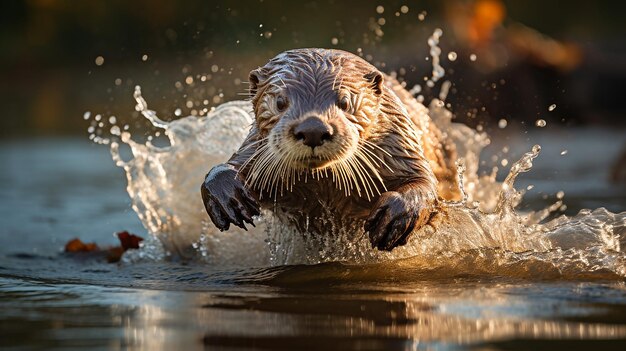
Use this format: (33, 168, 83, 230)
(201, 49, 458, 251)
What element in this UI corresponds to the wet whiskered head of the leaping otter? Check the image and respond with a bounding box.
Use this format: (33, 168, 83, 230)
(247, 49, 387, 198)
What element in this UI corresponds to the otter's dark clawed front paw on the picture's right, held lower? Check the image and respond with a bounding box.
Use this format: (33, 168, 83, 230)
(365, 191, 429, 251)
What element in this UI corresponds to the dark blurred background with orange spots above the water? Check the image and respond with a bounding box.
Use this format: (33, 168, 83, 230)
(0, 0, 626, 138)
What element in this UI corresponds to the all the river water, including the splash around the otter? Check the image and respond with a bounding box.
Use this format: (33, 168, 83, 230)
(0, 32, 626, 350)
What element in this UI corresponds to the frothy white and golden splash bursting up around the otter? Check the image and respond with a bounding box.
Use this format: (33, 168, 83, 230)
(86, 32, 626, 279)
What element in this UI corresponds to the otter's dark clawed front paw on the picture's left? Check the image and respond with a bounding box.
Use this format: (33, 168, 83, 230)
(201, 165, 261, 231)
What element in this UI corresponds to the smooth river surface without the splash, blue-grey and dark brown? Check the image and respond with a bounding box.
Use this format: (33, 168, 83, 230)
(0, 128, 626, 350)
